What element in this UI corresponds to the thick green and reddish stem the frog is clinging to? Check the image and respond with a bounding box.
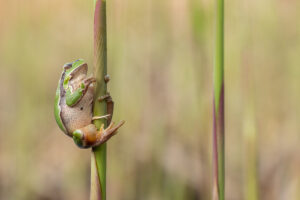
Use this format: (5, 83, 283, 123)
(90, 0, 107, 200)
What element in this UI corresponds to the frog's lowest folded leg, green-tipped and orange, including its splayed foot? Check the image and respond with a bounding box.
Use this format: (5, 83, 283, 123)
(72, 121, 125, 148)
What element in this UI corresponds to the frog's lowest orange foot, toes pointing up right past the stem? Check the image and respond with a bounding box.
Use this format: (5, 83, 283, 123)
(93, 120, 125, 147)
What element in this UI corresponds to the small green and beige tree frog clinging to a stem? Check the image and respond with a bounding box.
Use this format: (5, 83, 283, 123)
(54, 59, 124, 148)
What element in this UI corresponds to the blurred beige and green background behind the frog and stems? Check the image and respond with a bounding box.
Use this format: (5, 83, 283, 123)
(0, 0, 300, 200)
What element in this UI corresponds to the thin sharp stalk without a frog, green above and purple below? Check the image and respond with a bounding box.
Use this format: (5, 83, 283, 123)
(213, 0, 225, 200)
